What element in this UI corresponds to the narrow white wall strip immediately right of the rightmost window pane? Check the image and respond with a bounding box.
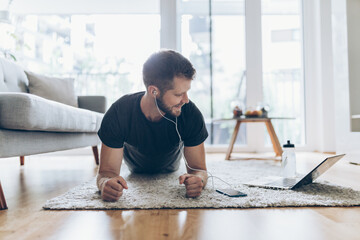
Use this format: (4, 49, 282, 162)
(303, 0, 336, 152)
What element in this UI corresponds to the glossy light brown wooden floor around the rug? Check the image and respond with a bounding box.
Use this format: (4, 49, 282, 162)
(0, 149, 360, 240)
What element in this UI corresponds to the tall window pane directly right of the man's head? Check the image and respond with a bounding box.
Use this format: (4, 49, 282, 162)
(178, 0, 246, 144)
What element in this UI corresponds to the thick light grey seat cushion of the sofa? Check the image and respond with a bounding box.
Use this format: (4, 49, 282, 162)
(0, 93, 103, 132)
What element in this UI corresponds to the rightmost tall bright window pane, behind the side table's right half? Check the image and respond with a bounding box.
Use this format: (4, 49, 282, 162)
(261, 0, 305, 145)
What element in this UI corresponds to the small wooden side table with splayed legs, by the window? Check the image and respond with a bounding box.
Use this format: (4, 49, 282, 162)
(214, 117, 295, 160)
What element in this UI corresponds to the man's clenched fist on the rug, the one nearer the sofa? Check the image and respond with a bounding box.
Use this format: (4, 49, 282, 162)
(101, 176, 128, 202)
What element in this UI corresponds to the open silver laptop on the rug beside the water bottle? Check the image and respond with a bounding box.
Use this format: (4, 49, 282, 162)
(244, 154, 345, 189)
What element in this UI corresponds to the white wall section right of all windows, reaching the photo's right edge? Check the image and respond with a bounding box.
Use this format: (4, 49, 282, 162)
(296, 0, 360, 156)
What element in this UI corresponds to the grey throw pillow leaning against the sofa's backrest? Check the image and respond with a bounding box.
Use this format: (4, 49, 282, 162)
(25, 71, 78, 107)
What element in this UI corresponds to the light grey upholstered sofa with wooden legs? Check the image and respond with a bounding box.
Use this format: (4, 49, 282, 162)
(0, 58, 106, 209)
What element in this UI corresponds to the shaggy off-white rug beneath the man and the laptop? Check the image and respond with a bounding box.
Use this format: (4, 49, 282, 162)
(43, 160, 360, 210)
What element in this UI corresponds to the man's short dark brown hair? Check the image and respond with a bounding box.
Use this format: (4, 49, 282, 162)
(143, 50, 196, 94)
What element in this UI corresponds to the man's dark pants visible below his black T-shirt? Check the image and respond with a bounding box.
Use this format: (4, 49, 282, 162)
(124, 142, 184, 173)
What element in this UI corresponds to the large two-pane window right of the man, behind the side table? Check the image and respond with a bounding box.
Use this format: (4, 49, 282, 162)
(178, 0, 305, 151)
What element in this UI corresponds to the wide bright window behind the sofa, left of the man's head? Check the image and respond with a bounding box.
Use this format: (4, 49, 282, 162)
(3, 14, 160, 105)
